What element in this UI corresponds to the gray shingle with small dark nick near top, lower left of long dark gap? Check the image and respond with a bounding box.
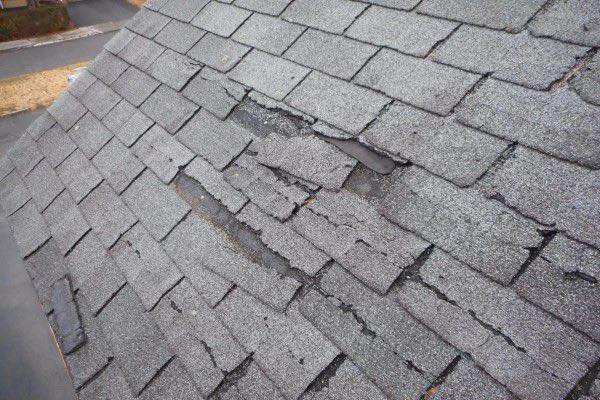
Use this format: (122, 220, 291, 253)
(109, 224, 183, 311)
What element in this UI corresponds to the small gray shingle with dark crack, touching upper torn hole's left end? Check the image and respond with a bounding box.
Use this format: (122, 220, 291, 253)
(182, 67, 247, 119)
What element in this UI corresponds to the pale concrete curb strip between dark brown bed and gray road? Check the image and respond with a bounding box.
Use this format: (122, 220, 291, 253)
(0, 19, 129, 53)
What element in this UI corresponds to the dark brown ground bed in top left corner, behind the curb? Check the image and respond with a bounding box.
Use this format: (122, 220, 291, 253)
(0, 4, 73, 42)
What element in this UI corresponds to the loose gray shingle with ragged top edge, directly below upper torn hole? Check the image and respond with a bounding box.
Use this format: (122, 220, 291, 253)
(258, 133, 357, 189)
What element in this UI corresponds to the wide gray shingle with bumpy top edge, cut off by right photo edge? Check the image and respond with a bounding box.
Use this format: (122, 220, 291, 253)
(456, 79, 600, 168)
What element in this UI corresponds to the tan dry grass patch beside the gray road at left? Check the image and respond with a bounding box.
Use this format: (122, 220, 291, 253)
(0, 61, 89, 117)
